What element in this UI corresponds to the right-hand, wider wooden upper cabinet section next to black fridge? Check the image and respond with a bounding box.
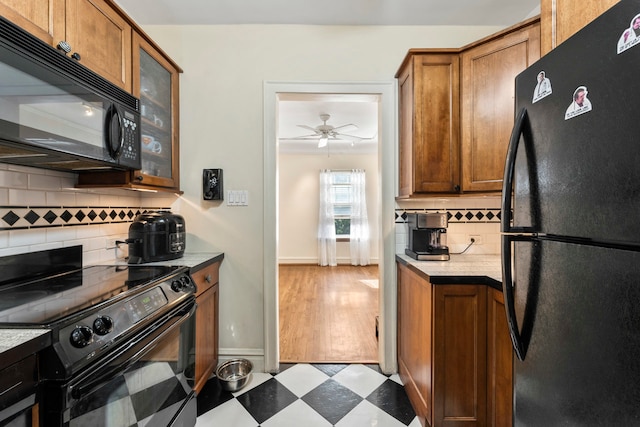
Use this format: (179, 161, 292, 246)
(461, 19, 540, 192)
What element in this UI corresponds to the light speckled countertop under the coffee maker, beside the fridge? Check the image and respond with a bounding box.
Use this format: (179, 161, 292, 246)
(396, 254, 502, 289)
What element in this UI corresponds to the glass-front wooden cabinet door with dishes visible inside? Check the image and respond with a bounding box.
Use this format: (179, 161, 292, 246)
(133, 34, 180, 190)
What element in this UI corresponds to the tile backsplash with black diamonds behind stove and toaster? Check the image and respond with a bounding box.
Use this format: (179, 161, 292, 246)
(0, 163, 176, 265)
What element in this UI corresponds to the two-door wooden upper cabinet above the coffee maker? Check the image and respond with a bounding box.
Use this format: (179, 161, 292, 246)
(396, 18, 540, 198)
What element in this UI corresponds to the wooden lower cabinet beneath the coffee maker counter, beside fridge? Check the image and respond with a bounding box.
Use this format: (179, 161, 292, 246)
(398, 263, 513, 427)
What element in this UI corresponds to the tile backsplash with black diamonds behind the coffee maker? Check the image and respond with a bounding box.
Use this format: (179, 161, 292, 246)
(395, 196, 502, 255)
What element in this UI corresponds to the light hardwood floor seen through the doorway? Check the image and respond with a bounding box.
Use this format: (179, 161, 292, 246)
(279, 265, 379, 363)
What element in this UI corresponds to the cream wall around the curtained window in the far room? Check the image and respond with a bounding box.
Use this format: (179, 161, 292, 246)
(278, 153, 379, 264)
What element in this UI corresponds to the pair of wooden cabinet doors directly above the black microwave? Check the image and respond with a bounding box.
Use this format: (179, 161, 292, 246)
(0, 0, 131, 92)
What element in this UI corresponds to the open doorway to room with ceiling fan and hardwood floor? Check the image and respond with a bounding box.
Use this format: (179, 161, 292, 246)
(277, 93, 380, 363)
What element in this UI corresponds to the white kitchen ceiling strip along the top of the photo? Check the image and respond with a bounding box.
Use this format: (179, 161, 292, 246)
(116, 0, 540, 27)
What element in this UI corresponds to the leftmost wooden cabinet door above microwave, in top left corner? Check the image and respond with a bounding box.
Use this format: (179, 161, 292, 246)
(0, 0, 65, 46)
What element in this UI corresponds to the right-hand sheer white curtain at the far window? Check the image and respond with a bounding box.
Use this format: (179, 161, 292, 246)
(349, 169, 371, 265)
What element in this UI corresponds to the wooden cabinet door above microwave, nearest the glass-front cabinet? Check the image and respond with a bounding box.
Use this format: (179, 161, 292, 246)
(65, 0, 131, 92)
